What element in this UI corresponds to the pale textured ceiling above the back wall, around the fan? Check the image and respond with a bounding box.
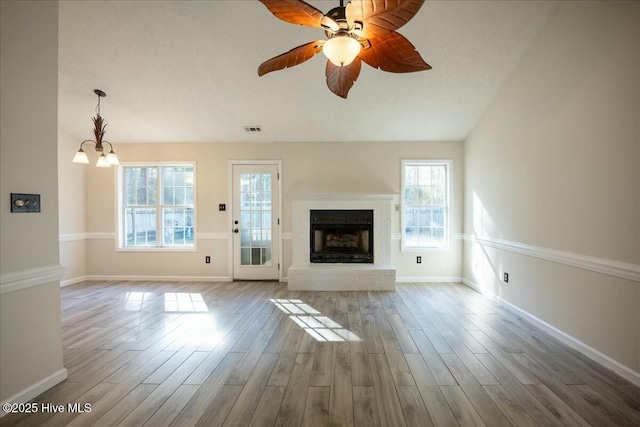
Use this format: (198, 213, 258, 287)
(59, 0, 555, 143)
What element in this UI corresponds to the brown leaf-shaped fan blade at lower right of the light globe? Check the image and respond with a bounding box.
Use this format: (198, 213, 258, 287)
(358, 31, 431, 73)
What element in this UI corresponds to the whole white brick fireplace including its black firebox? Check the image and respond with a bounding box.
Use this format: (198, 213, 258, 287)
(288, 193, 396, 291)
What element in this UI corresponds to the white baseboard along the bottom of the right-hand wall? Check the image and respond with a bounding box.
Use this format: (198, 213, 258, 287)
(462, 279, 640, 386)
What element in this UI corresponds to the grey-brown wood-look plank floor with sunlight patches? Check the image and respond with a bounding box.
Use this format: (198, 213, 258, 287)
(1, 282, 640, 427)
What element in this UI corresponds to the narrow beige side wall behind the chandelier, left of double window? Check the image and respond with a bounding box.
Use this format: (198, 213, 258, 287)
(58, 129, 87, 285)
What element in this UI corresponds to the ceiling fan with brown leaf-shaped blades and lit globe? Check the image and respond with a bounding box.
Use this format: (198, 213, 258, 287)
(258, 0, 431, 98)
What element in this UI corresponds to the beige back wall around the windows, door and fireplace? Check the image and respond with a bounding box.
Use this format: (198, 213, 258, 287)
(82, 142, 463, 277)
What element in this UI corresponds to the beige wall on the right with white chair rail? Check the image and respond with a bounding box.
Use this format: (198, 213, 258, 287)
(463, 2, 640, 373)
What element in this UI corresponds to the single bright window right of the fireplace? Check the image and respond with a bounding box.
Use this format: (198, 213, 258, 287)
(402, 160, 451, 250)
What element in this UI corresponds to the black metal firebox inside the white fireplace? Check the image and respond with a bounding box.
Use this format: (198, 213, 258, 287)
(310, 210, 373, 264)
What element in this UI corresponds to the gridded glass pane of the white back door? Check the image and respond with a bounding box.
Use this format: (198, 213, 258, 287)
(240, 173, 271, 265)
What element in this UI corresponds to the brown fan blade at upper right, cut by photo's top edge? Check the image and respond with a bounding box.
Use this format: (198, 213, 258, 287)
(346, 0, 424, 39)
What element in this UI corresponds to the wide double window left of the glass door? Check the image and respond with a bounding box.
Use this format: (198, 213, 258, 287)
(118, 163, 195, 249)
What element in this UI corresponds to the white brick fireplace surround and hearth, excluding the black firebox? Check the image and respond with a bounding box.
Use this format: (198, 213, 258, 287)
(287, 193, 398, 291)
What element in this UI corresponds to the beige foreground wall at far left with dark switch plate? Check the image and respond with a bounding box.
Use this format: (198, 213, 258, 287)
(0, 1, 63, 401)
